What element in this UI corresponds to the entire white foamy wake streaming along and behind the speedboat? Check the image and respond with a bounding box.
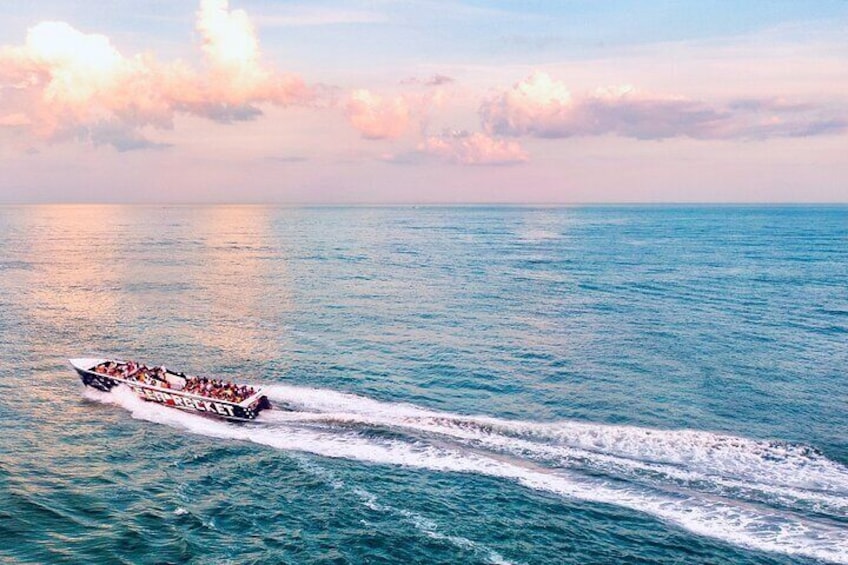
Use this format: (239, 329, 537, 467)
(86, 385, 848, 564)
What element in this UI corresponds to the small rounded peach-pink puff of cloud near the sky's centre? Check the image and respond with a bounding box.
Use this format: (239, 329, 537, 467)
(345, 89, 410, 139)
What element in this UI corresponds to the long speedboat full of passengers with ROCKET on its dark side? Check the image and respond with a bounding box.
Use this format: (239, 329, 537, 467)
(69, 358, 271, 421)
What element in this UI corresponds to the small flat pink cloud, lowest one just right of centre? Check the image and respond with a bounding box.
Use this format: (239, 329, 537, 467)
(418, 131, 527, 165)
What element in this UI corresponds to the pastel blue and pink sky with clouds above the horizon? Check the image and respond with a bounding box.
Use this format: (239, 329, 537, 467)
(0, 0, 848, 204)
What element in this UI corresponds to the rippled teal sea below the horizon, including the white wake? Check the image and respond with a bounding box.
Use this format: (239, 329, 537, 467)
(0, 205, 848, 565)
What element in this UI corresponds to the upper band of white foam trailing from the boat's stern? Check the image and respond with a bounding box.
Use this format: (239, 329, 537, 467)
(266, 385, 848, 495)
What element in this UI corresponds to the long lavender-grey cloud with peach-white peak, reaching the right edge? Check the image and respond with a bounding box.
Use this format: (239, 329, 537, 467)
(480, 72, 848, 139)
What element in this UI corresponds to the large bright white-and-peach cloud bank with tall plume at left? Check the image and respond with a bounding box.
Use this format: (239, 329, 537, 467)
(0, 0, 313, 150)
